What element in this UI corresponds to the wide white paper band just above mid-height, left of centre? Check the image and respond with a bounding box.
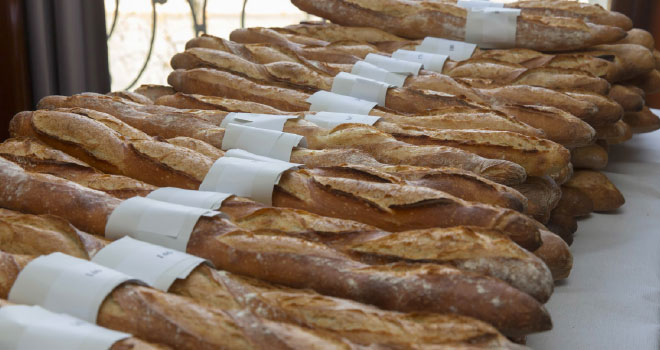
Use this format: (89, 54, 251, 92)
(222, 124, 307, 161)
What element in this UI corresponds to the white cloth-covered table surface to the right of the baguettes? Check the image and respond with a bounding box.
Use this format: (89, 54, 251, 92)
(527, 110, 660, 350)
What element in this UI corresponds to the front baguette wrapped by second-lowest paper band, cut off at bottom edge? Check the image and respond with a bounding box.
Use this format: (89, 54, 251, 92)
(0, 252, 378, 350)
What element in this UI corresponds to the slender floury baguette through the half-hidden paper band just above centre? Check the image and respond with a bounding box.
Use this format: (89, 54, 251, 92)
(39, 95, 525, 183)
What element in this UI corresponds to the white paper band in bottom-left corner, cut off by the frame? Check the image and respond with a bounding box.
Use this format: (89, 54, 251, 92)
(0, 305, 131, 350)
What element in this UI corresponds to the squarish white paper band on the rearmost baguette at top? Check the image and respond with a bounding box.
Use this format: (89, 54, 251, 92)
(465, 7, 520, 49)
